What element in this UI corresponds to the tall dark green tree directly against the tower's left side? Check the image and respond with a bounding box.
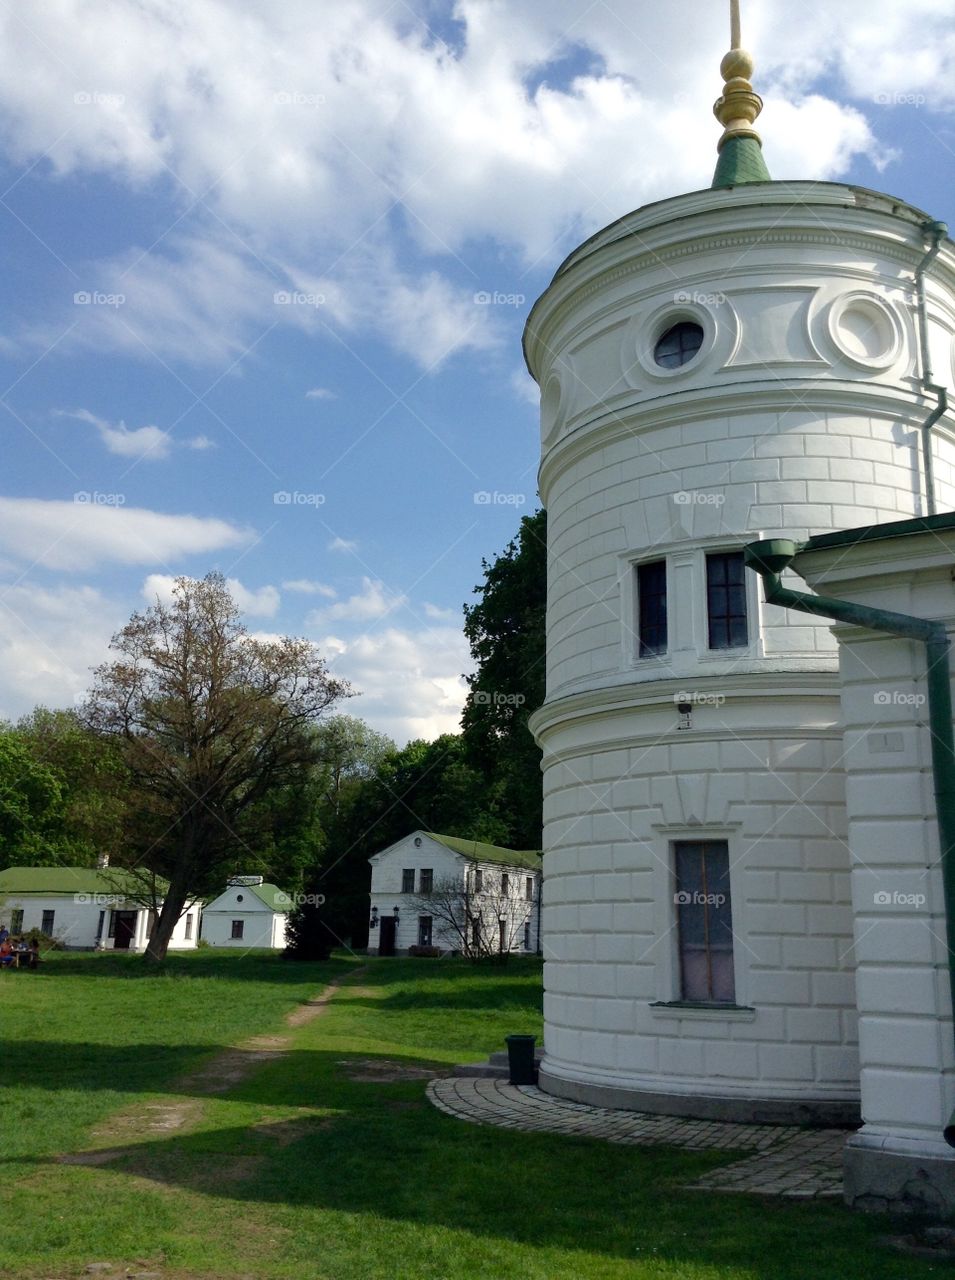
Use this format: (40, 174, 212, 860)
(461, 509, 547, 849)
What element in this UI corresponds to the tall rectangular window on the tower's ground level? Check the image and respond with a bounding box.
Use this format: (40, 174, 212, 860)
(673, 840, 736, 1004)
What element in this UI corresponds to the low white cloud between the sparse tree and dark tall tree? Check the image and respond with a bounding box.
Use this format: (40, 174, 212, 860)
(317, 627, 471, 742)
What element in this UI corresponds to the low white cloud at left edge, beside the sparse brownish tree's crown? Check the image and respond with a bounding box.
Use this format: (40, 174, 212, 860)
(0, 584, 120, 719)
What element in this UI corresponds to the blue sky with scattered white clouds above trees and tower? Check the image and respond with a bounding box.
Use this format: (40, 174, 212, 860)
(0, 0, 955, 741)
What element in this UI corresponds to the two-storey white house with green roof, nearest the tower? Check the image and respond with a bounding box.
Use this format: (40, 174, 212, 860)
(369, 831, 542, 955)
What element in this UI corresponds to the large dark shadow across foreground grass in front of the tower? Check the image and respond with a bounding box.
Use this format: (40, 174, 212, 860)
(8, 1051, 937, 1280)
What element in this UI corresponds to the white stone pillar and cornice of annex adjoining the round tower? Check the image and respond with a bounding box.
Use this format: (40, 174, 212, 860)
(796, 534, 955, 1165)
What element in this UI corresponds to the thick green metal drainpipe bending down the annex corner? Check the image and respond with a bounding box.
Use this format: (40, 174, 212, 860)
(742, 538, 955, 1147)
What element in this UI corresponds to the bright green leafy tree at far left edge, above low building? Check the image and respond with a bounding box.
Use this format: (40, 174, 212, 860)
(0, 724, 63, 868)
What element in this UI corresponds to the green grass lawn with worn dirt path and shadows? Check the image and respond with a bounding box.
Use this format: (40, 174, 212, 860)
(0, 951, 943, 1280)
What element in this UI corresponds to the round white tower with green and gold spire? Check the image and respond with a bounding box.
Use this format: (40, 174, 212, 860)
(525, 6, 955, 1157)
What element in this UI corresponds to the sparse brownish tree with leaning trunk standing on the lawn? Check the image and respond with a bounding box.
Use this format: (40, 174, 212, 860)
(83, 573, 349, 963)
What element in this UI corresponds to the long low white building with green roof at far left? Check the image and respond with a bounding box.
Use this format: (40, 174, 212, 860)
(0, 865, 201, 951)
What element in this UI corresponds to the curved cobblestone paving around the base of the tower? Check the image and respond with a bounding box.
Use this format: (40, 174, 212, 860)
(428, 1076, 847, 1199)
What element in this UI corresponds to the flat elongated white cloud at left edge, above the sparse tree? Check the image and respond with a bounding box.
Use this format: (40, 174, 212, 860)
(0, 493, 252, 570)
